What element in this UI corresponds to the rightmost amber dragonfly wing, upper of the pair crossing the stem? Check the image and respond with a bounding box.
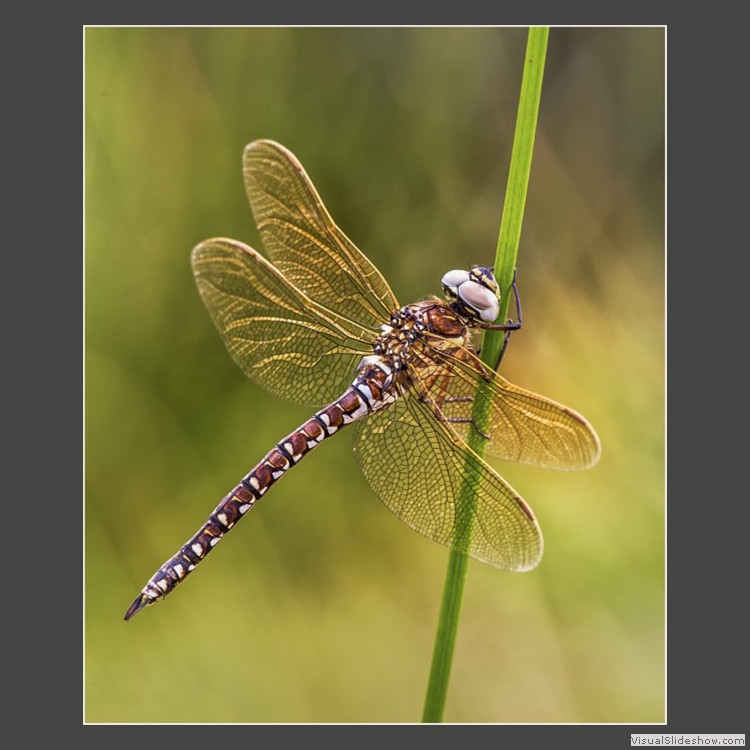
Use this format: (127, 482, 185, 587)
(413, 338, 601, 470)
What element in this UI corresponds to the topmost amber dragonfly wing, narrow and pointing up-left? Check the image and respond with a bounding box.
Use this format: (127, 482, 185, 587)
(243, 140, 399, 327)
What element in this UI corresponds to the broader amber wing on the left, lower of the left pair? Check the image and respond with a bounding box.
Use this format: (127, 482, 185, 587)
(192, 239, 375, 405)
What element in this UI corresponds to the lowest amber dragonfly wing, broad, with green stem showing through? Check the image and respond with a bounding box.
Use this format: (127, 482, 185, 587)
(354, 396, 542, 571)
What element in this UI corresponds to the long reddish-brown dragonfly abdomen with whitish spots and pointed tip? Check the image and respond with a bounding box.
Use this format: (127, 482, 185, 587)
(125, 358, 396, 620)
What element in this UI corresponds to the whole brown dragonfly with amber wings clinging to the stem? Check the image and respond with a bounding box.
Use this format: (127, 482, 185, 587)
(125, 140, 600, 620)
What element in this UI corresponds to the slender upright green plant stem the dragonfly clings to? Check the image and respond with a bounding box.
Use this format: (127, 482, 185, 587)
(422, 27, 549, 722)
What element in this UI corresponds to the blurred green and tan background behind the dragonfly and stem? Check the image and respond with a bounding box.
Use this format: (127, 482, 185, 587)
(85, 28, 665, 723)
